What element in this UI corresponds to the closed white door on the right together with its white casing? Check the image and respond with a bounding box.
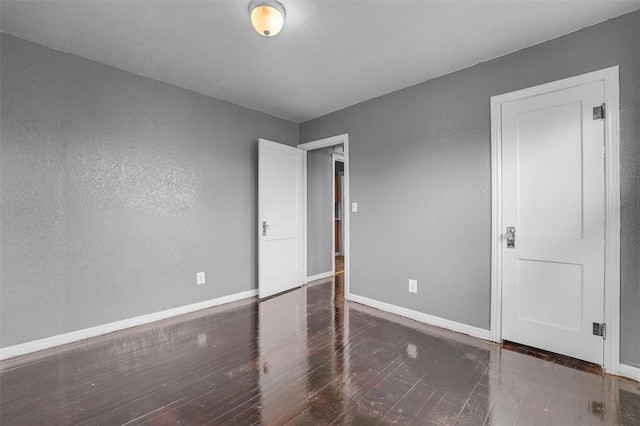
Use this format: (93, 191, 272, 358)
(491, 67, 620, 373)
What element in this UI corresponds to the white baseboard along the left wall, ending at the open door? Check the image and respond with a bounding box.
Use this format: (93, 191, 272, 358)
(0, 290, 258, 360)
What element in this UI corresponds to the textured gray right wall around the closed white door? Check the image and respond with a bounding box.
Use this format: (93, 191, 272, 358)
(300, 11, 640, 366)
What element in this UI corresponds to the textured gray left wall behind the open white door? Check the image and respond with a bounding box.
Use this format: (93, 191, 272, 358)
(0, 34, 298, 347)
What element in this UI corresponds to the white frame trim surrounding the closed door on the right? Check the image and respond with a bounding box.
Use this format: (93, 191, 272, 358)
(490, 65, 620, 374)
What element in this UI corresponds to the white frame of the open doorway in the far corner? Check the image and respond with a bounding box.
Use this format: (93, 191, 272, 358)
(298, 133, 351, 299)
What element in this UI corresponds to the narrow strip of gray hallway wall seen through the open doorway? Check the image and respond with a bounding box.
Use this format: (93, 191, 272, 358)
(307, 148, 333, 276)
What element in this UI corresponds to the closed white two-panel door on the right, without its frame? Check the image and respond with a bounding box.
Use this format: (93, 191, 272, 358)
(502, 81, 605, 365)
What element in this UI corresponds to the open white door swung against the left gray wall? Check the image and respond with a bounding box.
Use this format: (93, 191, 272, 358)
(258, 139, 306, 298)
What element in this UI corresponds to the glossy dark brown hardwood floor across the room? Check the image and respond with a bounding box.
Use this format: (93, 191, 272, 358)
(0, 275, 640, 426)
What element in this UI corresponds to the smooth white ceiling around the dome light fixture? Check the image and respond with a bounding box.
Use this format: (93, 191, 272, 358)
(0, 0, 640, 122)
